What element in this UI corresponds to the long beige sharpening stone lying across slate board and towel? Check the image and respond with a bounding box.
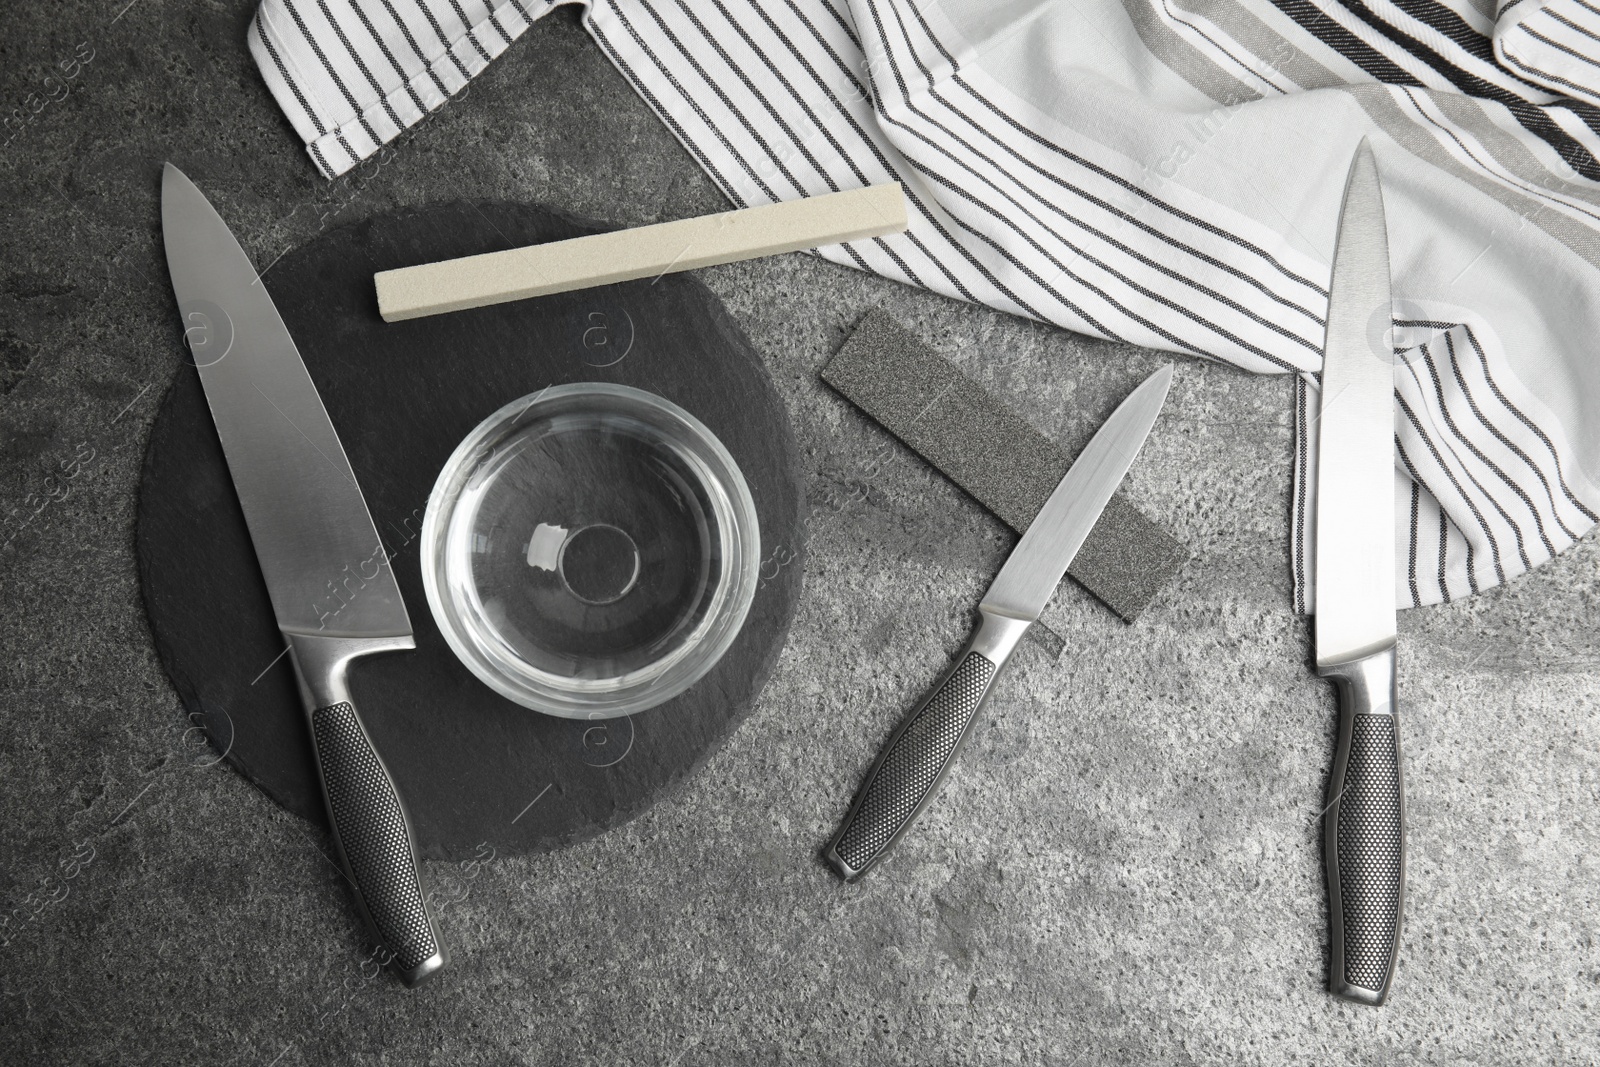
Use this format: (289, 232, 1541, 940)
(373, 182, 907, 322)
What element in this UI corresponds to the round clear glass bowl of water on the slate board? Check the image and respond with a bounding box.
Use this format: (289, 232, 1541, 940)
(422, 382, 762, 718)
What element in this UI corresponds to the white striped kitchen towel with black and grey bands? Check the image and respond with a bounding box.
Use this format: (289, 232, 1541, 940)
(250, 0, 1600, 609)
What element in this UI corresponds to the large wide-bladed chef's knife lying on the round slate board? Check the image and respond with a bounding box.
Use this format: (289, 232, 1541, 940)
(162, 163, 446, 985)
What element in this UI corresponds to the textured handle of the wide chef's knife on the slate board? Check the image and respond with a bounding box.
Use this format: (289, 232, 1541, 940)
(288, 633, 448, 985)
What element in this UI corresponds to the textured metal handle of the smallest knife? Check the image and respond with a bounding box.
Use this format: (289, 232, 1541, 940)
(822, 608, 1029, 881)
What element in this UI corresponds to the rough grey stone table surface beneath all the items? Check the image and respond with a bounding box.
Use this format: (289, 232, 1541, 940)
(0, 0, 1600, 1067)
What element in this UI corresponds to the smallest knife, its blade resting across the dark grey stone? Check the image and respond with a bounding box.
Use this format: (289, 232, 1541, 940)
(822, 365, 1173, 881)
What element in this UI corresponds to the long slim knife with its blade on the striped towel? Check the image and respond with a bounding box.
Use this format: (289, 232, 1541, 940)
(1314, 139, 1405, 1005)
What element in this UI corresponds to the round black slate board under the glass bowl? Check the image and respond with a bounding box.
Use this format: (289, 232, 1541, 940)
(138, 203, 805, 859)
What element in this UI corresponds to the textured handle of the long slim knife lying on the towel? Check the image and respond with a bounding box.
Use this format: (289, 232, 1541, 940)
(1318, 646, 1405, 1005)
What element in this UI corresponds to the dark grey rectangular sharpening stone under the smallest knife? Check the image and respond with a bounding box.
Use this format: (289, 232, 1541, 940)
(822, 309, 1189, 622)
